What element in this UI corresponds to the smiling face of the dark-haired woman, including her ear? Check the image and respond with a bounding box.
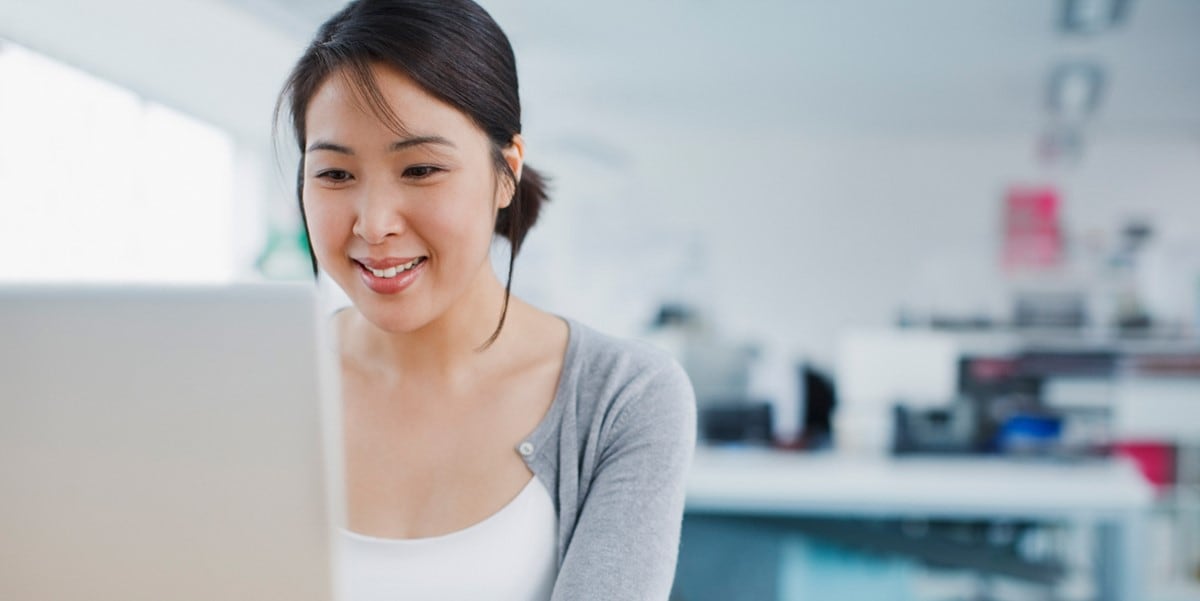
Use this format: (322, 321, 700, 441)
(302, 66, 522, 332)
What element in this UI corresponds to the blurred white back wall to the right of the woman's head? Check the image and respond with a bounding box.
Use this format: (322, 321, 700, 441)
(516, 130, 1200, 359)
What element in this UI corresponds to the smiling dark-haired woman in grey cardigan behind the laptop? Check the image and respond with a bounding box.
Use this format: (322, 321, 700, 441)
(274, 0, 695, 601)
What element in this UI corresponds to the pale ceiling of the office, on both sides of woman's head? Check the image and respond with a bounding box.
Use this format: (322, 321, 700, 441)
(0, 0, 1200, 149)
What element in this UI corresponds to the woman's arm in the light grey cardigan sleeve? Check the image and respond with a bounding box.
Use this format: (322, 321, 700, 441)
(551, 361, 696, 601)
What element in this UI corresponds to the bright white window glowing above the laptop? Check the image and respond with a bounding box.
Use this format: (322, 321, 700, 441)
(0, 42, 235, 283)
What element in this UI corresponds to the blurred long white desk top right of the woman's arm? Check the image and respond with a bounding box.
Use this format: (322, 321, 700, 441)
(686, 446, 1153, 519)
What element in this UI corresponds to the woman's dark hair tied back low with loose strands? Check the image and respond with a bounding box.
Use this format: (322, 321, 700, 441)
(275, 0, 547, 348)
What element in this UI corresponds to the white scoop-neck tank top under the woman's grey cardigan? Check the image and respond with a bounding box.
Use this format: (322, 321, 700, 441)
(340, 477, 558, 601)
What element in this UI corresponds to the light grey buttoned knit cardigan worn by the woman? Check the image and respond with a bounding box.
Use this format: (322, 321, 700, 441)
(516, 319, 696, 601)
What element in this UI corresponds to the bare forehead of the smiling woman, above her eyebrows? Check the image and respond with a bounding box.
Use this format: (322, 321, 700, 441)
(305, 64, 486, 145)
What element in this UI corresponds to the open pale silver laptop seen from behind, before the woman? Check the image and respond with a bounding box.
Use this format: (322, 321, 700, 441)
(0, 284, 344, 601)
